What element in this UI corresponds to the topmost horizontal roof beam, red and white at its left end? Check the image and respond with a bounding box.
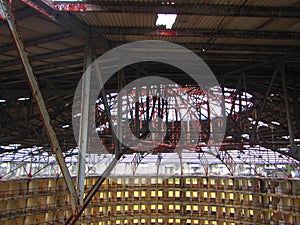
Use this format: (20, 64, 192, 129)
(53, 1, 300, 18)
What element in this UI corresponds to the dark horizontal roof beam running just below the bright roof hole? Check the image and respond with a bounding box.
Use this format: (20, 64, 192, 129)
(90, 26, 300, 40)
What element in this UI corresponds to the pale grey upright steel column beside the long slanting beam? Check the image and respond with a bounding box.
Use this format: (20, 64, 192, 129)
(76, 38, 93, 205)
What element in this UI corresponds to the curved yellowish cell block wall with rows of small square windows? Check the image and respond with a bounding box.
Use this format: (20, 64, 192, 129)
(0, 176, 300, 225)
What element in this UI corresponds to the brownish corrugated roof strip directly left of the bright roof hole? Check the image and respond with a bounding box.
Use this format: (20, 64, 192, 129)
(76, 12, 157, 27)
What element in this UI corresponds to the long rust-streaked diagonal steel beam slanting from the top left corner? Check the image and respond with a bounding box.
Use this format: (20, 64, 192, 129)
(0, 0, 78, 209)
